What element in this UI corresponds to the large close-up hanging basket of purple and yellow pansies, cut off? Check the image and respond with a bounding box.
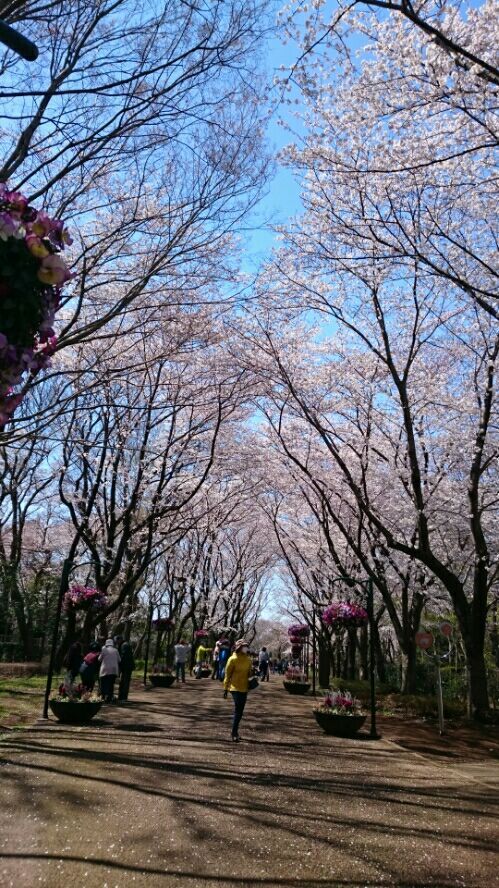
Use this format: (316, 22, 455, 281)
(0, 183, 72, 430)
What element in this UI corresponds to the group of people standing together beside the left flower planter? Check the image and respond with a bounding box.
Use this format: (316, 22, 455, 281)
(65, 635, 135, 703)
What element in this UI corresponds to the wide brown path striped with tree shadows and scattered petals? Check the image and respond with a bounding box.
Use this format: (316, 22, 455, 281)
(0, 679, 499, 888)
